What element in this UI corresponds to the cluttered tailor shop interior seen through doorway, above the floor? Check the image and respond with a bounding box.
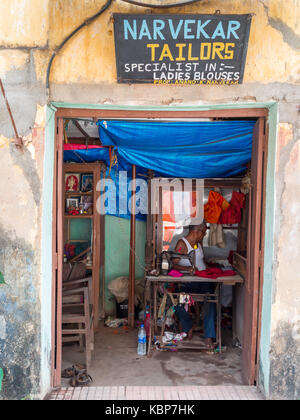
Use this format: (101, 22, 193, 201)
(61, 119, 255, 381)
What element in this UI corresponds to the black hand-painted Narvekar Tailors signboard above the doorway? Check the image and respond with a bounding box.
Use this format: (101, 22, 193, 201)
(113, 13, 252, 85)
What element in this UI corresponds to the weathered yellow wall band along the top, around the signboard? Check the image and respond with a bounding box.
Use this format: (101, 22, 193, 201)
(0, 0, 300, 84)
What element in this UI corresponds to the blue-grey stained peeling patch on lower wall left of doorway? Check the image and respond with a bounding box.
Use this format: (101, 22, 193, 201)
(0, 224, 41, 400)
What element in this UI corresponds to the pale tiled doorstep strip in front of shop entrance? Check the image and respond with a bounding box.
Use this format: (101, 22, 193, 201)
(47, 385, 264, 401)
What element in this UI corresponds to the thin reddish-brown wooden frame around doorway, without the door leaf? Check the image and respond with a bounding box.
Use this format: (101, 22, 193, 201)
(51, 104, 269, 388)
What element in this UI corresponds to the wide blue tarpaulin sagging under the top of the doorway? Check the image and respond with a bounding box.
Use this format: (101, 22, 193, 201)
(98, 121, 255, 178)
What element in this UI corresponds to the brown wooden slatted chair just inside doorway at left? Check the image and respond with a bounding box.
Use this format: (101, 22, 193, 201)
(62, 277, 94, 369)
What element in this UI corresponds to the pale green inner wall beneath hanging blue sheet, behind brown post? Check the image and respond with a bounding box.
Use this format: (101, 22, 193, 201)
(105, 216, 146, 314)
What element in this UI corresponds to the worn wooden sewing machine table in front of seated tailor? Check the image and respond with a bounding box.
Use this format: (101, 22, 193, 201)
(146, 274, 244, 356)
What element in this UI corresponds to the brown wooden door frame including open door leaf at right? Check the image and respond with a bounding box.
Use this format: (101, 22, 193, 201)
(52, 109, 268, 386)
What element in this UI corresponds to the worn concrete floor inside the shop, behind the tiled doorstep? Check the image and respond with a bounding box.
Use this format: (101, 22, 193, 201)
(62, 327, 243, 387)
